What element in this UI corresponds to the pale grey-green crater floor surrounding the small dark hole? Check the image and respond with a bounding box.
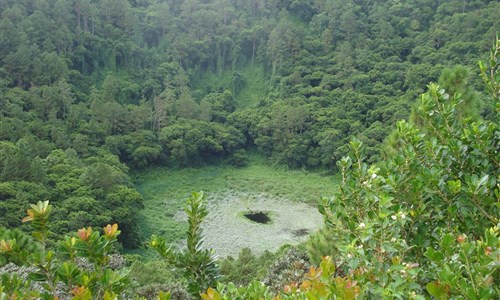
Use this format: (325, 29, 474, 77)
(191, 191, 323, 258)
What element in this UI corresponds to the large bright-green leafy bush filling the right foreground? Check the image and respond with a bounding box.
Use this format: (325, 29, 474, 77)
(203, 38, 500, 299)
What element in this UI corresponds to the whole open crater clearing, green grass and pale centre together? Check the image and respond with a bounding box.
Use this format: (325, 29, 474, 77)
(135, 162, 337, 257)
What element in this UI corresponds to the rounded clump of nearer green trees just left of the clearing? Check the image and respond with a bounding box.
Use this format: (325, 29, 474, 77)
(0, 146, 142, 246)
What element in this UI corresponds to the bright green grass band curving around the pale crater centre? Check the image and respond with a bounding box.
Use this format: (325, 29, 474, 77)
(133, 159, 337, 255)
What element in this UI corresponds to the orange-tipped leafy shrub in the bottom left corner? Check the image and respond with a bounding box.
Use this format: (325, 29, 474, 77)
(0, 201, 135, 300)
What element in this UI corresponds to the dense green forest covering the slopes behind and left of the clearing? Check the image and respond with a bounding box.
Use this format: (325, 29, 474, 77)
(0, 0, 500, 245)
